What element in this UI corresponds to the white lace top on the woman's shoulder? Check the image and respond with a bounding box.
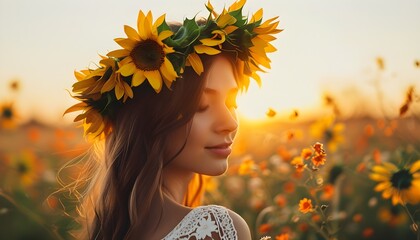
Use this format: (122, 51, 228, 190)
(162, 205, 238, 240)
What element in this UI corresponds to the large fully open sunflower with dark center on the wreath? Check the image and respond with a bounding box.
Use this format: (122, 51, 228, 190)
(108, 11, 178, 92)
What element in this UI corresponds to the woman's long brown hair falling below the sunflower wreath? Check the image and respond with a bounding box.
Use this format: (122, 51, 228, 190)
(67, 54, 243, 239)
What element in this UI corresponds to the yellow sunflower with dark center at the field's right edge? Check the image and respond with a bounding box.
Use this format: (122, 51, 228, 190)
(369, 160, 420, 205)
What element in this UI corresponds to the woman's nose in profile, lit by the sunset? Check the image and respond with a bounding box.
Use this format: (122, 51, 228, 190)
(214, 106, 238, 134)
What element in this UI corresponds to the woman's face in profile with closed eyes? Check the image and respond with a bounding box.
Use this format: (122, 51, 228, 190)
(167, 56, 238, 176)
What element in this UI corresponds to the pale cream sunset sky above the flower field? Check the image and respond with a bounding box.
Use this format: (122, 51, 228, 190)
(0, 0, 420, 124)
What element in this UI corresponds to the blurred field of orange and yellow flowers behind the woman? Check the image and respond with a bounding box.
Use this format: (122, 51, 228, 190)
(0, 67, 420, 240)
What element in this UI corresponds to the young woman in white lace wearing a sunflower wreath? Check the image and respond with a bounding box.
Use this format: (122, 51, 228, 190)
(66, 1, 280, 240)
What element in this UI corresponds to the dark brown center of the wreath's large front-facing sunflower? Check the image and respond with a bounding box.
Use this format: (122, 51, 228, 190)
(130, 39, 165, 71)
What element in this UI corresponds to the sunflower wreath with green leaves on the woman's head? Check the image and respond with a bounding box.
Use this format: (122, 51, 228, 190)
(64, 0, 281, 139)
